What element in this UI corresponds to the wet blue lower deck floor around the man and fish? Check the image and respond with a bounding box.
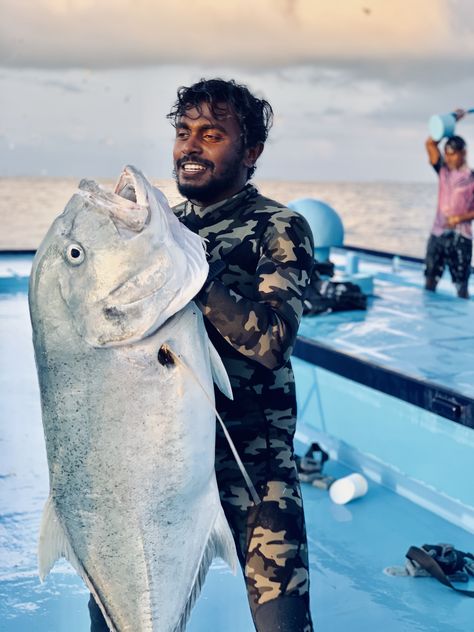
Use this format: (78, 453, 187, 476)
(0, 254, 474, 632)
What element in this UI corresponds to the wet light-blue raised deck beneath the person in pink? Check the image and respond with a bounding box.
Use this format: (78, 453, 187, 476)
(298, 250, 474, 399)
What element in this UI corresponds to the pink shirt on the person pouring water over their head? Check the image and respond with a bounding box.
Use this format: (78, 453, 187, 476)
(431, 165, 474, 239)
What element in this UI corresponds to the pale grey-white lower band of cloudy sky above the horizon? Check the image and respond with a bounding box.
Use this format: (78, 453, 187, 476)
(0, 60, 474, 181)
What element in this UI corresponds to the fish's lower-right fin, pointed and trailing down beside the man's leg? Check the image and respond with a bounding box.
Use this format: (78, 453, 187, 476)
(173, 507, 238, 632)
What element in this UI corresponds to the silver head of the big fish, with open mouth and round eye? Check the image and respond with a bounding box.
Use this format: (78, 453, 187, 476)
(30, 166, 208, 347)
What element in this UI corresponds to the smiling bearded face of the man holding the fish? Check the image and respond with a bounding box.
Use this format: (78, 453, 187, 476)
(173, 103, 248, 205)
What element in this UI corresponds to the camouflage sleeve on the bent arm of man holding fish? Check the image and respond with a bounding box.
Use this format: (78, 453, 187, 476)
(196, 210, 313, 369)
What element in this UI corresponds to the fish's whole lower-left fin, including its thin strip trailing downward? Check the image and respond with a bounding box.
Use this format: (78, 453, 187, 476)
(38, 496, 117, 632)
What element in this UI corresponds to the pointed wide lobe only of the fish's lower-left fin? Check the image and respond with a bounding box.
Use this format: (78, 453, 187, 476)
(38, 496, 82, 581)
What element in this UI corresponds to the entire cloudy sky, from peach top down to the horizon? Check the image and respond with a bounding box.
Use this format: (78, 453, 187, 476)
(0, 0, 474, 182)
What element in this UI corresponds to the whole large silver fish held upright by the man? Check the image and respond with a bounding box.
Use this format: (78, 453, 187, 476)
(29, 167, 236, 632)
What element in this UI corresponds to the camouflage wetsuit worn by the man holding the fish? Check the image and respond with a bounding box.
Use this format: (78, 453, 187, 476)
(175, 185, 313, 632)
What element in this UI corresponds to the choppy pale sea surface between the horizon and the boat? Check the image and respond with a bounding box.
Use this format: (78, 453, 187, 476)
(0, 177, 436, 257)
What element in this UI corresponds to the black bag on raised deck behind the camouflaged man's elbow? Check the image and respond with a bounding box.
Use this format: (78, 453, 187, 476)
(303, 264, 367, 316)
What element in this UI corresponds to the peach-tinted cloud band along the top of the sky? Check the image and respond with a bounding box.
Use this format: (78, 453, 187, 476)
(0, 0, 474, 68)
